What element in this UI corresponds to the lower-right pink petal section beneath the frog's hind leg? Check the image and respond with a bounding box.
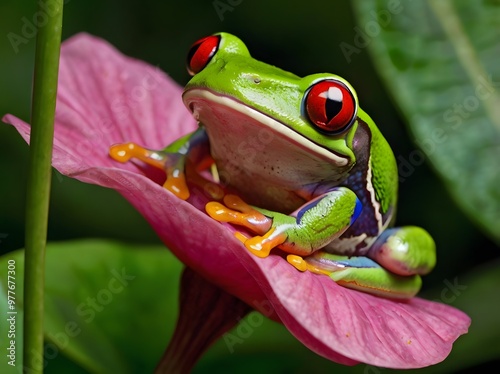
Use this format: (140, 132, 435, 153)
(245, 256, 470, 368)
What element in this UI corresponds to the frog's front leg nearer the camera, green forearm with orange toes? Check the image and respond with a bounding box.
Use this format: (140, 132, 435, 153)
(206, 187, 362, 257)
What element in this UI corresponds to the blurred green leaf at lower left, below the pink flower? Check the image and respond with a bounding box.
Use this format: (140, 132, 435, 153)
(0, 240, 182, 373)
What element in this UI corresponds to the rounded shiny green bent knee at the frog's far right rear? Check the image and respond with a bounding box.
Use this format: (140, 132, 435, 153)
(368, 226, 436, 275)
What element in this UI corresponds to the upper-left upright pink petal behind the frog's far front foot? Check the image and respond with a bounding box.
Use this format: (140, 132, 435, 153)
(4, 34, 197, 176)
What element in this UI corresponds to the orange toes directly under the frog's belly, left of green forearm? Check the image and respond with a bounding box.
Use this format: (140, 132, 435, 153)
(205, 195, 272, 234)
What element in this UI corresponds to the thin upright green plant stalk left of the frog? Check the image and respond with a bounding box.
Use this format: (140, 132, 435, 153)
(23, 0, 63, 373)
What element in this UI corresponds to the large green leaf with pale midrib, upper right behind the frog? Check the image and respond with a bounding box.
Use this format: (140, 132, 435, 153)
(354, 0, 500, 242)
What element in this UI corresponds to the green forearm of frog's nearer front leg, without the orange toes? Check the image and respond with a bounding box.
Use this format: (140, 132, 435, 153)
(280, 187, 362, 256)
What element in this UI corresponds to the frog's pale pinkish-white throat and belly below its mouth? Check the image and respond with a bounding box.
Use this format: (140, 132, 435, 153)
(205, 108, 343, 213)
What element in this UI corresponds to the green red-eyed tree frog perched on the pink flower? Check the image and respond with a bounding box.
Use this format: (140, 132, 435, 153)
(110, 33, 436, 299)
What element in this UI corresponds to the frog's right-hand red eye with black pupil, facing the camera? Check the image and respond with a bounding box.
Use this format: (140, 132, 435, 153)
(305, 80, 357, 134)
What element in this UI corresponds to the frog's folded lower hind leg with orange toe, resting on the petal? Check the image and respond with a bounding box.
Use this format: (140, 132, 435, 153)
(287, 250, 422, 299)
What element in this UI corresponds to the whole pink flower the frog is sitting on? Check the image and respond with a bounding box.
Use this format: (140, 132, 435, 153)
(3, 34, 470, 368)
